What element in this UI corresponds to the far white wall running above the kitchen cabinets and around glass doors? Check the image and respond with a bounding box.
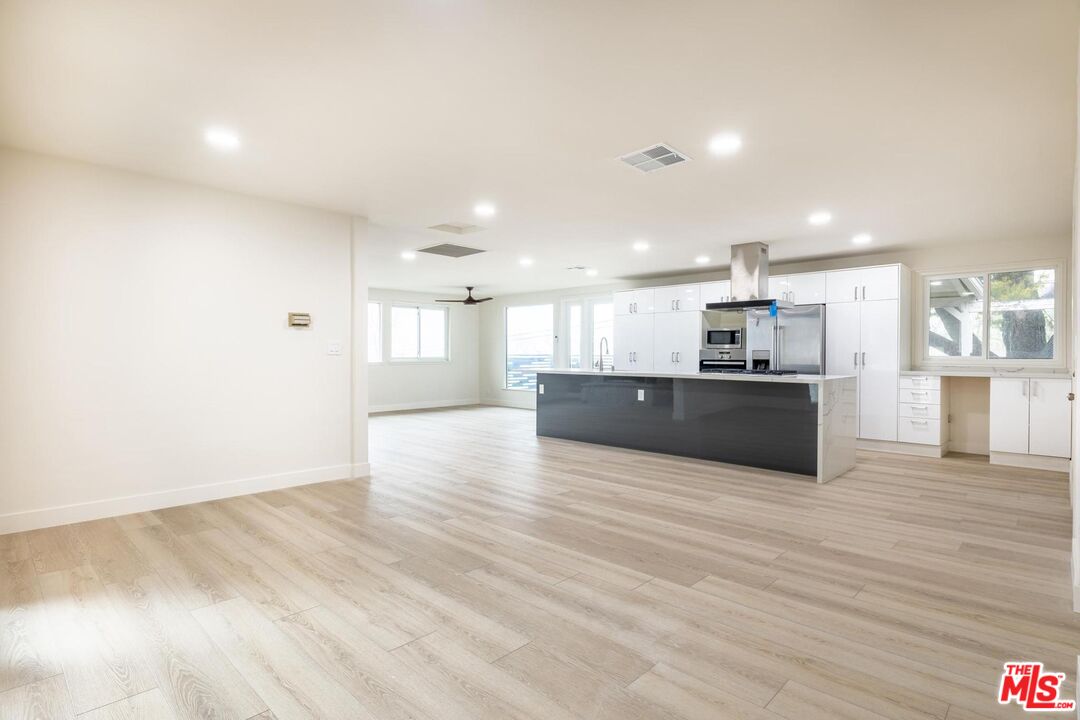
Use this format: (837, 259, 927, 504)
(480, 237, 1071, 408)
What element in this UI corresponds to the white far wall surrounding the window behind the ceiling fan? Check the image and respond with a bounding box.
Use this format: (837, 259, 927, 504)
(367, 288, 480, 412)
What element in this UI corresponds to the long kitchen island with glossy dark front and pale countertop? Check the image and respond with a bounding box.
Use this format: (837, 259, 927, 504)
(537, 370, 858, 483)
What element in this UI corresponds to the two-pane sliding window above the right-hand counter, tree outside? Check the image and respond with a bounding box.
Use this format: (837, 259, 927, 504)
(923, 268, 1057, 362)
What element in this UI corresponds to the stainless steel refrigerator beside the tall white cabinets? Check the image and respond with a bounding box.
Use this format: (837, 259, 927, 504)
(746, 305, 825, 375)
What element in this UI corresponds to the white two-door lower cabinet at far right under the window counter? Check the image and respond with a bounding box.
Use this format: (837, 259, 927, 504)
(990, 378, 1072, 458)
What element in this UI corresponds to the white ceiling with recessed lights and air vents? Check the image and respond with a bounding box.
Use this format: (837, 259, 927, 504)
(0, 0, 1080, 295)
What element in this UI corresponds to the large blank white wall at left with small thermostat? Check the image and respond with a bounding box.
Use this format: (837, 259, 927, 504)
(0, 151, 367, 532)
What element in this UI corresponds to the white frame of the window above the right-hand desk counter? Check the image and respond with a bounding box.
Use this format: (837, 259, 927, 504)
(917, 259, 1071, 370)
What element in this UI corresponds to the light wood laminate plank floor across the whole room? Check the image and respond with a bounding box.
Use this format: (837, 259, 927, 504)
(0, 408, 1080, 720)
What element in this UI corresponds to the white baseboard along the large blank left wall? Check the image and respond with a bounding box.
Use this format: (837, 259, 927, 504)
(0, 463, 354, 534)
